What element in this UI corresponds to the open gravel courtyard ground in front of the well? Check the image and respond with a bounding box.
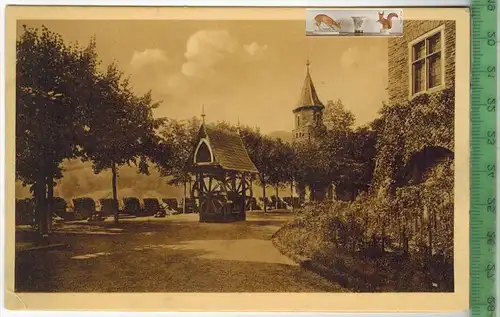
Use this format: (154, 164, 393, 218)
(16, 212, 342, 292)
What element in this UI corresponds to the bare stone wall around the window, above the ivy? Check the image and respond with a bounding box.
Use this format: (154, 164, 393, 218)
(388, 20, 456, 104)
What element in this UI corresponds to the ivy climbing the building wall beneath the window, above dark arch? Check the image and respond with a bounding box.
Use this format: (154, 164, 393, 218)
(373, 87, 455, 193)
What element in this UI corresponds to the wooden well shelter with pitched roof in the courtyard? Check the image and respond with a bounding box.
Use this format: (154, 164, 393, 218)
(188, 123, 259, 222)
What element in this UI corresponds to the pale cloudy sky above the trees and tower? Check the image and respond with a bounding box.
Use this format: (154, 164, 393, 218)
(18, 20, 387, 133)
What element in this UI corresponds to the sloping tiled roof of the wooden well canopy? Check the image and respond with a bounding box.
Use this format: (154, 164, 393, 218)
(192, 124, 259, 173)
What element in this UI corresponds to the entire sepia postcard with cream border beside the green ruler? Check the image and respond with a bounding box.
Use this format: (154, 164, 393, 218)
(5, 6, 469, 312)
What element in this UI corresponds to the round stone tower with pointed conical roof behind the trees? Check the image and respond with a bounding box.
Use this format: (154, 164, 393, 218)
(292, 61, 325, 141)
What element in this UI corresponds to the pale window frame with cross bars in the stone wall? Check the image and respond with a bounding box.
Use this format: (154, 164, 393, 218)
(408, 24, 446, 100)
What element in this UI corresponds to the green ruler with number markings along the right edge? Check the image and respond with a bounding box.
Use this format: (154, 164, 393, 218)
(470, 0, 500, 317)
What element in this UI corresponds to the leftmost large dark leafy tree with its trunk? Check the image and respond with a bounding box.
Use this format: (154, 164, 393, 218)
(16, 26, 98, 234)
